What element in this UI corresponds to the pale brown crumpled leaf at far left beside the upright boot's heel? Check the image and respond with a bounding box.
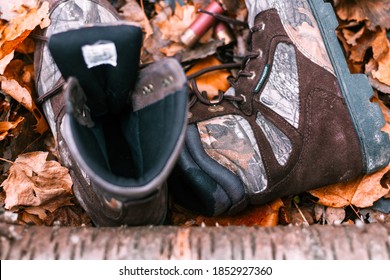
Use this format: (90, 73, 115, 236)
(1, 152, 72, 219)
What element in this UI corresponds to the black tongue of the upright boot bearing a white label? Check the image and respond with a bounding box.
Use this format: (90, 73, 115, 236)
(49, 25, 142, 117)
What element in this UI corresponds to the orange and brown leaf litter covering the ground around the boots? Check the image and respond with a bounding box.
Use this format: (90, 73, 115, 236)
(0, 0, 390, 226)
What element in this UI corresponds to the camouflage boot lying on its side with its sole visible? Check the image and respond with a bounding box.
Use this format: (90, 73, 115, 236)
(171, 0, 390, 215)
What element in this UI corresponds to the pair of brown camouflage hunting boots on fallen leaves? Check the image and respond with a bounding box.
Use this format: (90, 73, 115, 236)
(35, 0, 390, 226)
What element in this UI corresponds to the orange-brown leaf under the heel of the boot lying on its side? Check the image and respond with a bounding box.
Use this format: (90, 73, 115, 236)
(309, 165, 390, 208)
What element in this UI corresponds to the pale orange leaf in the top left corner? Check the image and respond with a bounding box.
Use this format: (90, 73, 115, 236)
(0, 0, 50, 59)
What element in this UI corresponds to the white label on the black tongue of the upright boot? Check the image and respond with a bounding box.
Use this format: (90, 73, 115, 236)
(81, 41, 117, 69)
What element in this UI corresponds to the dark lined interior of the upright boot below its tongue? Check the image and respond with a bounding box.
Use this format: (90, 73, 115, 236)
(69, 89, 186, 187)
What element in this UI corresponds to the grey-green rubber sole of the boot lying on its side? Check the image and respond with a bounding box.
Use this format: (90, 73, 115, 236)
(308, 0, 390, 173)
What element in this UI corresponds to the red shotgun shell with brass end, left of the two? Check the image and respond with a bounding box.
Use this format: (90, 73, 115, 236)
(180, 1, 223, 47)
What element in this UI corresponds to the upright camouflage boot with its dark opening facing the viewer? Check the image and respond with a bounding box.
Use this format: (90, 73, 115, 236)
(35, 0, 187, 226)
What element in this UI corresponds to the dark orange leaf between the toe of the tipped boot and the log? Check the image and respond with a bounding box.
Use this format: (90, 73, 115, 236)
(196, 199, 284, 226)
